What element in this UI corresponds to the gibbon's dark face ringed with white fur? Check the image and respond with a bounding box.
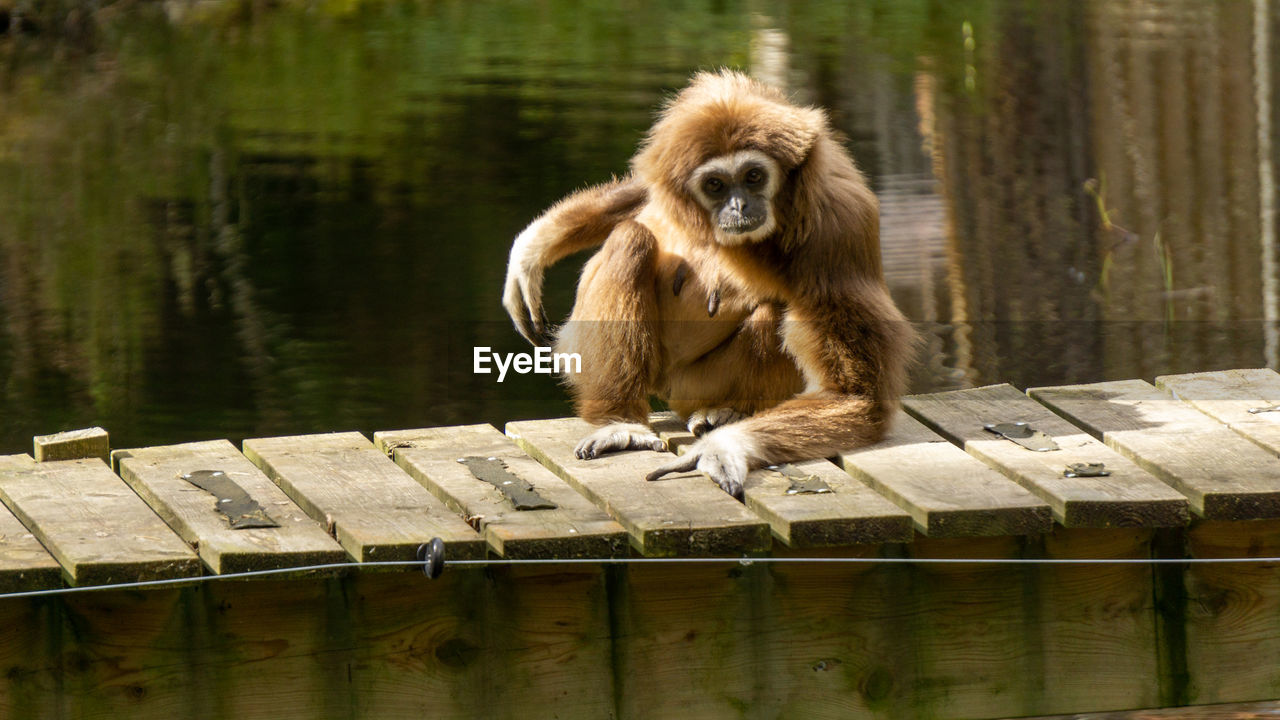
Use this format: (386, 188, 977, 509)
(687, 150, 782, 245)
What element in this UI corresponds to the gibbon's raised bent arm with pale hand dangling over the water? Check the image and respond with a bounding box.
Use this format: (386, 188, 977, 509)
(502, 176, 649, 346)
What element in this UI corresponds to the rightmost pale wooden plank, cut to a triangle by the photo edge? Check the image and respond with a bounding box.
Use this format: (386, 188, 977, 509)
(1156, 368, 1280, 455)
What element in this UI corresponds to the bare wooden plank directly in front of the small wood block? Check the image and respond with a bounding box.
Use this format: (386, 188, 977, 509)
(0, 455, 200, 585)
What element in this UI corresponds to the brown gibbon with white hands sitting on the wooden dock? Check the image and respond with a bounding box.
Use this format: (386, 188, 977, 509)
(503, 70, 914, 498)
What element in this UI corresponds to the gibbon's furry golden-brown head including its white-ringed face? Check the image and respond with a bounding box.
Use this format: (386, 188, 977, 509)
(631, 70, 828, 245)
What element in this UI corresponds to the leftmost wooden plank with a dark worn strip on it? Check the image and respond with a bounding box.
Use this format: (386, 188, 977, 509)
(111, 439, 347, 574)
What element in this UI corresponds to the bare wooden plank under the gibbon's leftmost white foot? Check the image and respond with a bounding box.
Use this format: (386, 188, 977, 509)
(507, 418, 771, 556)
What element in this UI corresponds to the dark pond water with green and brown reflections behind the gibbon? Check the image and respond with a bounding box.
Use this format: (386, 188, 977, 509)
(0, 0, 1280, 452)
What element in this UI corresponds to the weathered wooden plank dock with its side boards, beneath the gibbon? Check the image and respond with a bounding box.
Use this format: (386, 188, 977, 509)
(0, 370, 1280, 719)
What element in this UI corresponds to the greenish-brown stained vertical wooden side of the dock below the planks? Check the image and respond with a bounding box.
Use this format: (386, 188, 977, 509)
(0, 521, 1280, 720)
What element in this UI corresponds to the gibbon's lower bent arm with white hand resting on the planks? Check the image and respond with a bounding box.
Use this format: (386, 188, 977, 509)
(648, 281, 914, 498)
